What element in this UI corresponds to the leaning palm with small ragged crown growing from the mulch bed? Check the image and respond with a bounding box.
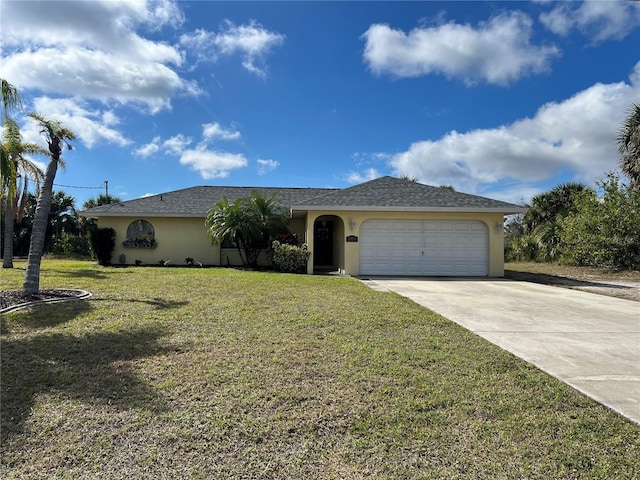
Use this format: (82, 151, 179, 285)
(22, 113, 76, 293)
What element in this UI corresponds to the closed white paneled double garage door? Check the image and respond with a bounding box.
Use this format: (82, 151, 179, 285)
(360, 220, 489, 276)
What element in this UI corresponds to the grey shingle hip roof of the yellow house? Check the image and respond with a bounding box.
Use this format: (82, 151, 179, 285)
(80, 176, 524, 217)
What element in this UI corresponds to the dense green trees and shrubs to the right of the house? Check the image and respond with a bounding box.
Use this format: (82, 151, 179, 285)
(505, 104, 640, 269)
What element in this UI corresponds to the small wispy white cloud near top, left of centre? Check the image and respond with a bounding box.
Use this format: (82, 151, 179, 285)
(180, 20, 285, 77)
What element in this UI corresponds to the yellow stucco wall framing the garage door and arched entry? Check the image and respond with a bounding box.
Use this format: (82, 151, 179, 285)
(307, 211, 504, 277)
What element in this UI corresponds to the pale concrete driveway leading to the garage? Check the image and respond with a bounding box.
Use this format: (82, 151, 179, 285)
(362, 277, 640, 424)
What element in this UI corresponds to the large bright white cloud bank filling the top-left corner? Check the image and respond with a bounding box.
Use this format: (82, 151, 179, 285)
(2, 0, 199, 113)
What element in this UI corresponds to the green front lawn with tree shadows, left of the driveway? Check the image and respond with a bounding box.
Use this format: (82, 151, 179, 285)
(0, 260, 640, 479)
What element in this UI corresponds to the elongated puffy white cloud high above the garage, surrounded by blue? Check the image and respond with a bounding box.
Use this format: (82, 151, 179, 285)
(362, 12, 558, 85)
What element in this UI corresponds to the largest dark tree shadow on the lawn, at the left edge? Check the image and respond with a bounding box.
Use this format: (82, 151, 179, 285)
(0, 328, 169, 443)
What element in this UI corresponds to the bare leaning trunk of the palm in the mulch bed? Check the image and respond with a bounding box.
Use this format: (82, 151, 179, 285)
(22, 159, 60, 293)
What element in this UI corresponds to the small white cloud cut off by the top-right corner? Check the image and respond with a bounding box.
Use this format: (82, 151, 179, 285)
(540, 1, 640, 42)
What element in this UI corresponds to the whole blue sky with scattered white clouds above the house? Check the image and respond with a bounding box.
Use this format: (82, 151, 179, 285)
(0, 0, 640, 207)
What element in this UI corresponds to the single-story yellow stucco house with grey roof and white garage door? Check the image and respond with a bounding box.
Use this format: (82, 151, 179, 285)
(80, 176, 526, 277)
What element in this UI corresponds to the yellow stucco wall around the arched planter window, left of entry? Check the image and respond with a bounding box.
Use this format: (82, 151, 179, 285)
(98, 217, 220, 265)
